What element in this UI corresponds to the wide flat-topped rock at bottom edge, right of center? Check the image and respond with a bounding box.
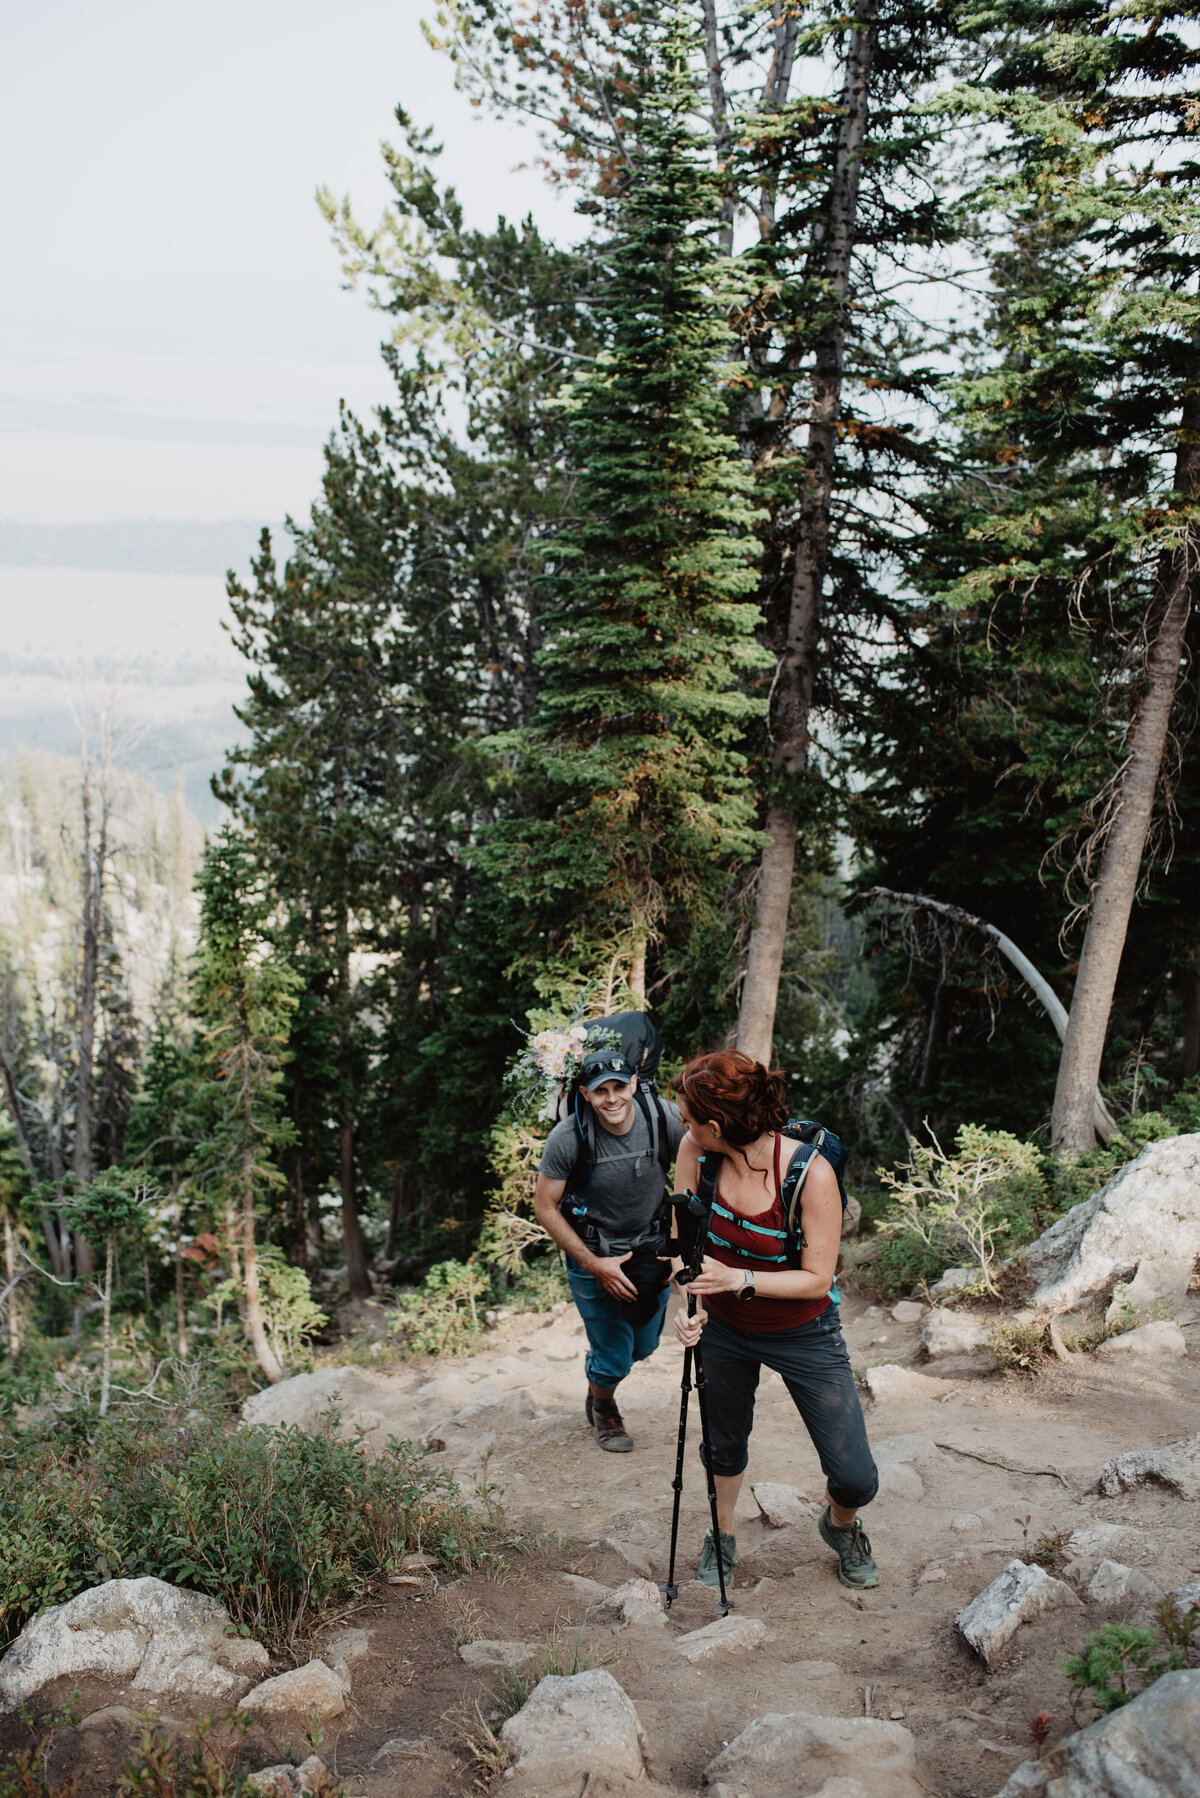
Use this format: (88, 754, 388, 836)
(705, 1712, 927, 1798)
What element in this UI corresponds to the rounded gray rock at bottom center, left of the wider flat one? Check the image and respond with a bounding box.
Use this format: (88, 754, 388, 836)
(500, 1667, 644, 1791)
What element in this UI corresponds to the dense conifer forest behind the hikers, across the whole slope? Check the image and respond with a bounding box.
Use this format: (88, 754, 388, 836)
(0, 0, 1200, 1388)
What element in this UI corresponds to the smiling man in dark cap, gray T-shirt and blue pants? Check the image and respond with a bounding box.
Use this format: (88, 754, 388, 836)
(533, 1048, 684, 1455)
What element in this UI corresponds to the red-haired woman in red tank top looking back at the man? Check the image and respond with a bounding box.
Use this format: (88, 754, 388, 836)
(675, 1050, 880, 1591)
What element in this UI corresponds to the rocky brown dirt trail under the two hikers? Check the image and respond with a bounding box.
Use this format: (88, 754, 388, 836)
(239, 1296, 1200, 1798)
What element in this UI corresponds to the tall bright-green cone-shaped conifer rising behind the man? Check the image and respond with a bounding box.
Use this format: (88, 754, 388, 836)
(482, 9, 766, 998)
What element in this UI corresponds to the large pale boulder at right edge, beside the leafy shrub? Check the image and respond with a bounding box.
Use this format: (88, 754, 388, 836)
(1018, 1135, 1200, 1311)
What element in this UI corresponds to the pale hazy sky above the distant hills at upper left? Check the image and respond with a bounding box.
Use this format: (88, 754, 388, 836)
(0, 0, 576, 525)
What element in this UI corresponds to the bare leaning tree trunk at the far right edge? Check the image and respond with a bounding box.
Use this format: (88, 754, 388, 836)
(1051, 418, 1200, 1154)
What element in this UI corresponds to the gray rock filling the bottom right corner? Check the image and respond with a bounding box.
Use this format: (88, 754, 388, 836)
(997, 1672, 1200, 1798)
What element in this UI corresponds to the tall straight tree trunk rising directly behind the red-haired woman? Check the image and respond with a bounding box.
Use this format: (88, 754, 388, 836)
(738, 0, 878, 1064)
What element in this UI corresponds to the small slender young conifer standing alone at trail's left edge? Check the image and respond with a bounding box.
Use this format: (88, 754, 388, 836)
(191, 825, 299, 1383)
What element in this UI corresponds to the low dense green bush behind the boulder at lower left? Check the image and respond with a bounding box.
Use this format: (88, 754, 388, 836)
(0, 1417, 500, 1649)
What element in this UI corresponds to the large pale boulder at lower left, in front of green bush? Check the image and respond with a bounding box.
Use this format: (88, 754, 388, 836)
(0, 1579, 270, 1710)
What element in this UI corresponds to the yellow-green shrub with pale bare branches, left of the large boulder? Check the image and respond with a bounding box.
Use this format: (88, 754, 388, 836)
(878, 1124, 1045, 1293)
